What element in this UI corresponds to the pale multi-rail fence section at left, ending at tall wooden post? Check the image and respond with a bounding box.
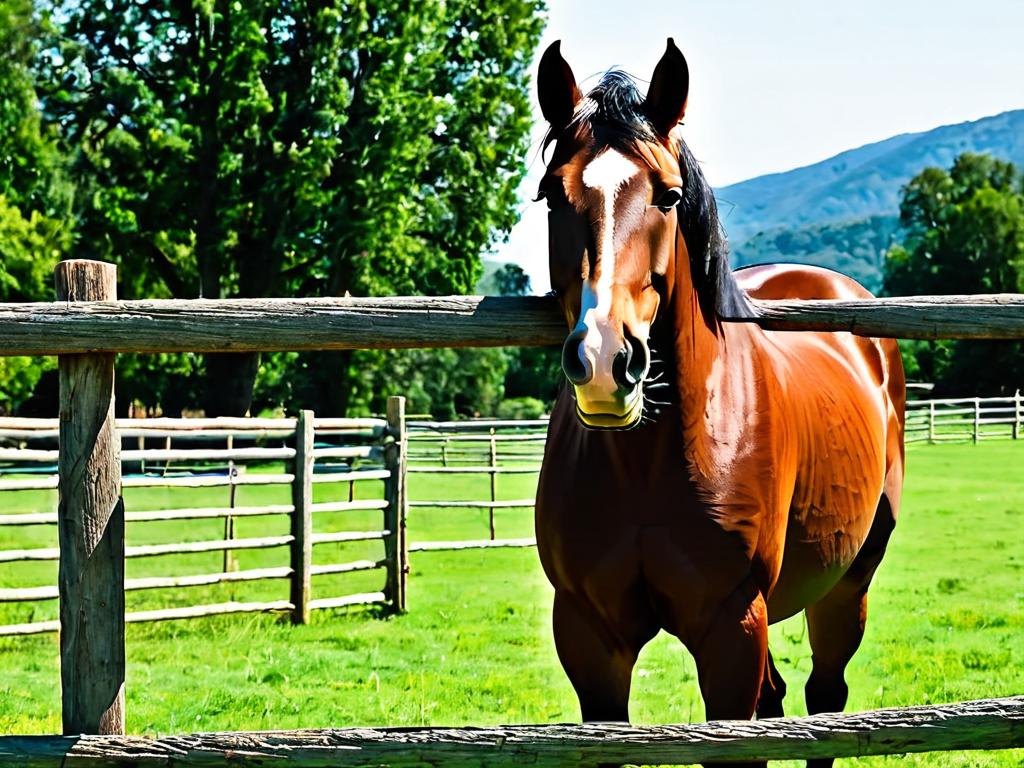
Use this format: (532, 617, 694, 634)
(0, 409, 408, 637)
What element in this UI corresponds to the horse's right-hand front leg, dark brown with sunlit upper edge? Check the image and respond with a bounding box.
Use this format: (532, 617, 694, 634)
(693, 580, 768, 768)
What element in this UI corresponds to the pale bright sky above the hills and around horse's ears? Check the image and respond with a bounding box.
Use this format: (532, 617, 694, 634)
(494, 0, 1024, 293)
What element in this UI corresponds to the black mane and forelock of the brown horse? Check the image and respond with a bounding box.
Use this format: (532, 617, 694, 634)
(544, 70, 754, 322)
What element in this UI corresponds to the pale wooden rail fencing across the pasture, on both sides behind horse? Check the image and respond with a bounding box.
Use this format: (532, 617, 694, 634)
(6, 390, 1024, 593)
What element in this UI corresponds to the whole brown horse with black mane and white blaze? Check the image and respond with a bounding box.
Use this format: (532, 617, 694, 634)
(537, 39, 904, 765)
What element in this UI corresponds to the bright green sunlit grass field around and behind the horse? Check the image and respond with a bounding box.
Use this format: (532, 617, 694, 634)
(0, 441, 1024, 767)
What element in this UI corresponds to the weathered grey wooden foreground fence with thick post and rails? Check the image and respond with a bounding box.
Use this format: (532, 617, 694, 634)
(0, 261, 1024, 765)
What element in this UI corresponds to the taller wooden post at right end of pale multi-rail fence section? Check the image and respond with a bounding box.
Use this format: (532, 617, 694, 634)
(384, 396, 409, 613)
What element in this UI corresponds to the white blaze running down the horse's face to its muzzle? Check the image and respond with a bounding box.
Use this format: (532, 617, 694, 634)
(575, 148, 639, 413)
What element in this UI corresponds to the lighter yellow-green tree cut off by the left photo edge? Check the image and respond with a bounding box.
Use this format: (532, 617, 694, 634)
(0, 0, 71, 416)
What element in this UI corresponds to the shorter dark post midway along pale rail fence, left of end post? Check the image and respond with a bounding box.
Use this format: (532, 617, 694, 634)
(291, 411, 313, 624)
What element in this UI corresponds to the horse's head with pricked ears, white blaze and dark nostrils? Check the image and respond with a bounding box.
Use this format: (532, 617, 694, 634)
(538, 38, 718, 429)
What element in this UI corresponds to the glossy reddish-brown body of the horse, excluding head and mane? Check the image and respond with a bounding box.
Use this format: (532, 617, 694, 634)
(537, 260, 904, 719)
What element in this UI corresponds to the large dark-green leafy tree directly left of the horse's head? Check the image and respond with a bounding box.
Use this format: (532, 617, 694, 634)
(41, 0, 542, 413)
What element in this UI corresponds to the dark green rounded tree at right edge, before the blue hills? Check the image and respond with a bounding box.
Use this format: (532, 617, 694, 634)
(885, 154, 1024, 394)
